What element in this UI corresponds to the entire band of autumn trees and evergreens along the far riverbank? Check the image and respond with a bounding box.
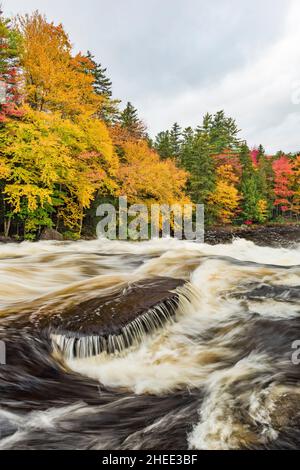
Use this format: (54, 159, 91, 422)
(0, 12, 300, 240)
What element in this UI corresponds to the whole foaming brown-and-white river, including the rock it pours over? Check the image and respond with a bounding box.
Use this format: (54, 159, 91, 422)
(0, 239, 300, 449)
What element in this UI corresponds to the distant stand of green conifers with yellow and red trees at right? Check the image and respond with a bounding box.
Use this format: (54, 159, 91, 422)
(152, 117, 300, 228)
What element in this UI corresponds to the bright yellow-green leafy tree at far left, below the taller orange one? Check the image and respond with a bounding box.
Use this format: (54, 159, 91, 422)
(0, 109, 118, 236)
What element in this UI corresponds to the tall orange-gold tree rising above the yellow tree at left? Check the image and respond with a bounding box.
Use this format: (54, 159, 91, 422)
(19, 12, 103, 119)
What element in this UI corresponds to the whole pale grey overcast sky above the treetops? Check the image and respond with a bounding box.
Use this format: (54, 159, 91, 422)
(2, 0, 300, 152)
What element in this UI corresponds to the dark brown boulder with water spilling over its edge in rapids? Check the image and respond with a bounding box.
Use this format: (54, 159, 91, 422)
(37, 277, 185, 357)
